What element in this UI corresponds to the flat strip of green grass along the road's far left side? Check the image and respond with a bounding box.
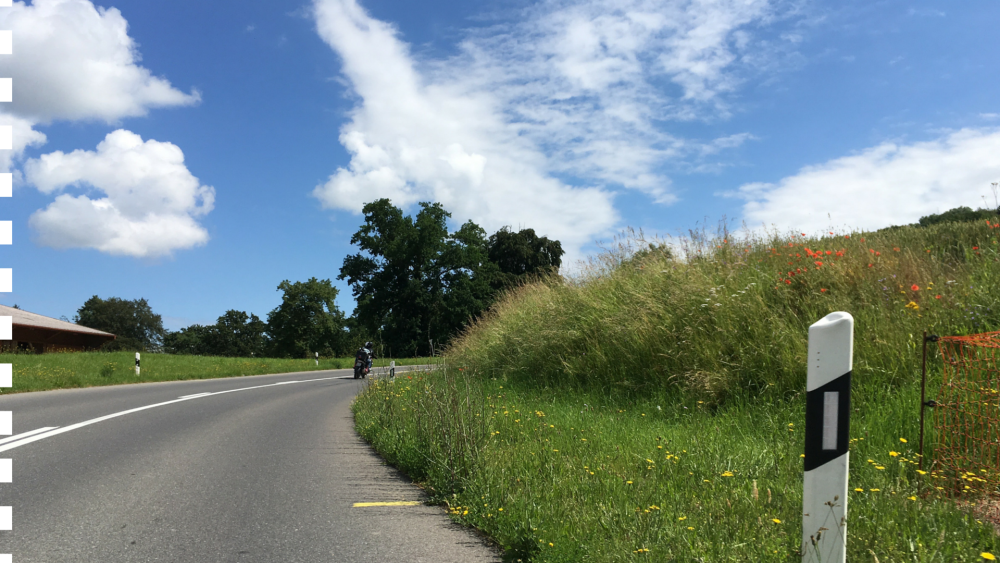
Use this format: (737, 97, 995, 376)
(0, 352, 433, 394)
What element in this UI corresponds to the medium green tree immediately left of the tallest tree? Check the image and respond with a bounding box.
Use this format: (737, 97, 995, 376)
(267, 278, 347, 358)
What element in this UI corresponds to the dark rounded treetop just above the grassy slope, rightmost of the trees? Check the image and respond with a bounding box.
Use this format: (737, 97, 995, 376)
(489, 227, 563, 290)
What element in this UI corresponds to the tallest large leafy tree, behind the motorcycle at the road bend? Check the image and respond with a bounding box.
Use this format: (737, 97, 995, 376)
(338, 199, 495, 355)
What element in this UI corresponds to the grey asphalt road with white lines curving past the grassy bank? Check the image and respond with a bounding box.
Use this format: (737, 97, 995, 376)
(0, 368, 499, 563)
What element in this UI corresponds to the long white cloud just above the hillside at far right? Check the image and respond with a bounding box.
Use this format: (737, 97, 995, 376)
(739, 129, 1000, 232)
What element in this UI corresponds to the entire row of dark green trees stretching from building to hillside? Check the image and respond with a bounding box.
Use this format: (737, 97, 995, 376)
(73, 199, 563, 358)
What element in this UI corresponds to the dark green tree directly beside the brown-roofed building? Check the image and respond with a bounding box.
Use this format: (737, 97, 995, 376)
(74, 295, 164, 351)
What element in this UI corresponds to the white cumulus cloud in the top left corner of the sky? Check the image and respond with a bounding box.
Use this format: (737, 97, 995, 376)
(0, 0, 200, 123)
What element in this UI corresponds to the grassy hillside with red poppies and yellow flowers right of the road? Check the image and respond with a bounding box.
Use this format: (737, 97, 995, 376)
(355, 221, 1000, 562)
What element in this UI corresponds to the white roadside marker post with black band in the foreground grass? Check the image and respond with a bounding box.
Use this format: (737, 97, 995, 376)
(801, 312, 854, 563)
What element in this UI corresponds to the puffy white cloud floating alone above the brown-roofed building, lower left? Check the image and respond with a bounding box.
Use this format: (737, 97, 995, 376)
(24, 129, 215, 257)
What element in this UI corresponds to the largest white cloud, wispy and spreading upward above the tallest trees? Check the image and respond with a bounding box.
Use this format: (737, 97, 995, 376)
(313, 0, 788, 256)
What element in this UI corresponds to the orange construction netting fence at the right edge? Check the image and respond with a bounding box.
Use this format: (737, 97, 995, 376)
(932, 331, 1000, 493)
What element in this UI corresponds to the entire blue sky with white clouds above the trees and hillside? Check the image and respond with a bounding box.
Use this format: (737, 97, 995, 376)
(0, 0, 1000, 329)
